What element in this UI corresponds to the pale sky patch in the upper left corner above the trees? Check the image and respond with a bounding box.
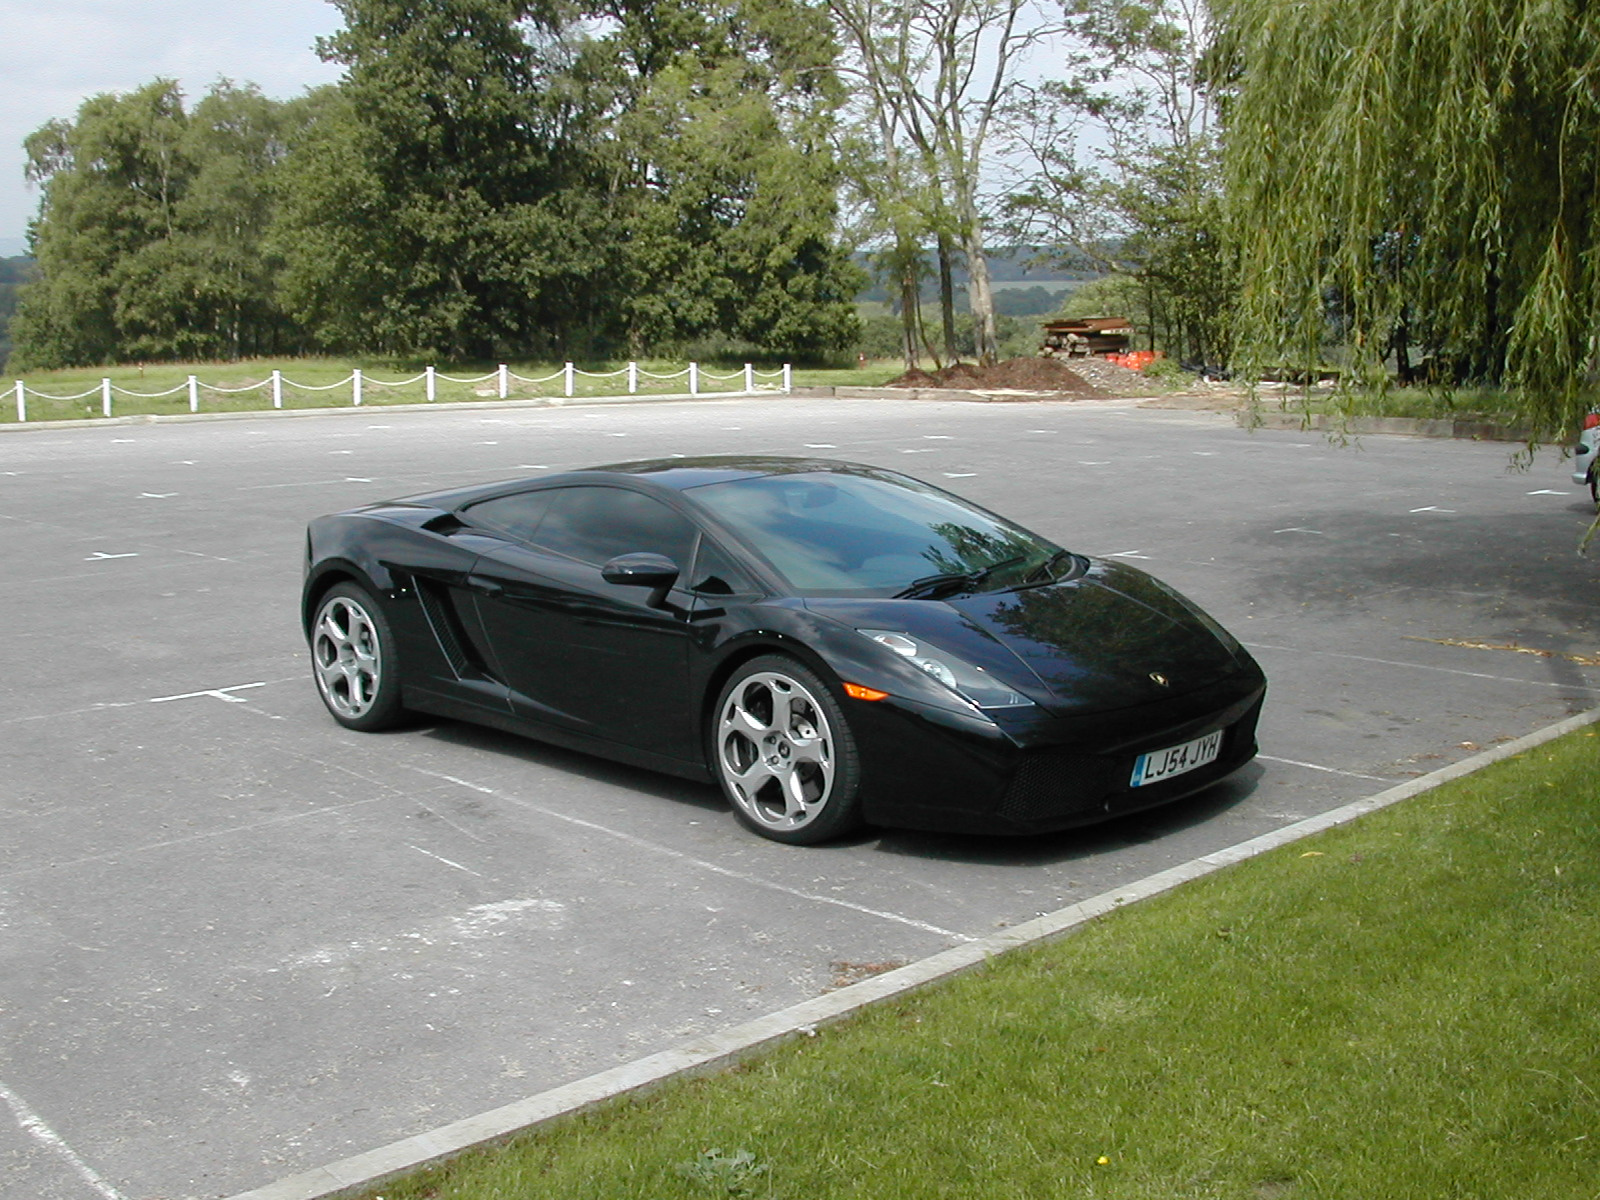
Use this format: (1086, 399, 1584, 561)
(0, 0, 341, 256)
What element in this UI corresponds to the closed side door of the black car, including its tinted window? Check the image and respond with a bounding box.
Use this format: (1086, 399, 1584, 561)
(464, 485, 699, 760)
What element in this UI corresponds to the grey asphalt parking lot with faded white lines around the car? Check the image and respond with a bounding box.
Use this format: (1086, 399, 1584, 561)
(0, 397, 1600, 1200)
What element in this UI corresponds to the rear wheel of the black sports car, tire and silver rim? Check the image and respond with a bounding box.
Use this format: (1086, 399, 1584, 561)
(310, 582, 405, 733)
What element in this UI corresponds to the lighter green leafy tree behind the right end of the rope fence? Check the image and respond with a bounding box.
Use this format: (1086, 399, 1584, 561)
(589, 0, 861, 355)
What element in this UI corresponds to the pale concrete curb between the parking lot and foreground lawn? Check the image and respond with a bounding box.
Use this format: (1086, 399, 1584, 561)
(216, 709, 1600, 1200)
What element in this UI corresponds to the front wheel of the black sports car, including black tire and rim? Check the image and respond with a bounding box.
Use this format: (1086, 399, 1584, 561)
(707, 654, 861, 845)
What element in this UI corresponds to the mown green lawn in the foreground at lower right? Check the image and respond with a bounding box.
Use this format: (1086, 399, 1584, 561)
(347, 728, 1600, 1200)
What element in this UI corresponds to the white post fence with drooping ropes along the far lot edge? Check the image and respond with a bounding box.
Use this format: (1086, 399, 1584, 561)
(13, 363, 794, 422)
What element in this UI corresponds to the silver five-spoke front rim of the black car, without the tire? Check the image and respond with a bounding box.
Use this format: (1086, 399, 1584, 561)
(717, 670, 835, 830)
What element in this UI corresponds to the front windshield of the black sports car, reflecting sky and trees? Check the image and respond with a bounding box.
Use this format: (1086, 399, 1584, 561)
(691, 472, 1066, 598)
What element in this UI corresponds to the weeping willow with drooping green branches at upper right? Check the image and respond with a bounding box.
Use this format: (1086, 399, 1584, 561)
(1216, 0, 1600, 430)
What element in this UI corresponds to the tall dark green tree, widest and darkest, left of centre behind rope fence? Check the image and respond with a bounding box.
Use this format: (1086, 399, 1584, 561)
(274, 0, 598, 358)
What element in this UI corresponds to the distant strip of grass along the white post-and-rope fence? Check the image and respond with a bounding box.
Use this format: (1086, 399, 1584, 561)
(0, 358, 800, 424)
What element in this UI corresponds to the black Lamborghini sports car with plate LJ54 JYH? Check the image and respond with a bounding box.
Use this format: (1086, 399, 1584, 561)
(302, 458, 1266, 843)
